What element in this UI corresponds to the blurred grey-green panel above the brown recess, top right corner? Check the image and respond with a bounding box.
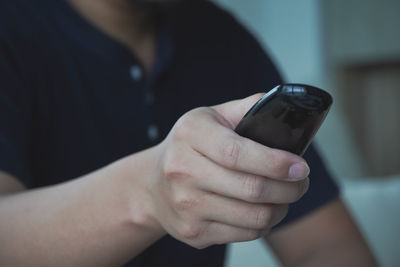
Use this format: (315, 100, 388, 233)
(321, 0, 400, 66)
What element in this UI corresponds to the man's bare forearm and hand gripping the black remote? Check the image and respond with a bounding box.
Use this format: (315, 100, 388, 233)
(0, 95, 308, 266)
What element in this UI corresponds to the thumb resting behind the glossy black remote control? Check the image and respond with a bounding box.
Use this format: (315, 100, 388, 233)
(211, 93, 264, 128)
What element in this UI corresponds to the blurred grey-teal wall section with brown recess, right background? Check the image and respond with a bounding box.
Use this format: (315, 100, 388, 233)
(321, 0, 400, 176)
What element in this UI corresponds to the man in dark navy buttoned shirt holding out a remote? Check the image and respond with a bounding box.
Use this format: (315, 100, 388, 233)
(0, 0, 375, 266)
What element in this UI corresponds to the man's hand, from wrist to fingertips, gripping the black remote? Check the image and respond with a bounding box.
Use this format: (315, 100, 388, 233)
(148, 95, 309, 248)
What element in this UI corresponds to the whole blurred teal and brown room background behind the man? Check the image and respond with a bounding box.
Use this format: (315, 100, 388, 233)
(209, 0, 400, 267)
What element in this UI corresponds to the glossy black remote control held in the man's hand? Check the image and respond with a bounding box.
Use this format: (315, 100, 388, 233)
(235, 83, 332, 155)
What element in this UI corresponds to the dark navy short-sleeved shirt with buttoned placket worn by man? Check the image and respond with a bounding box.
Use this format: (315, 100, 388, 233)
(0, 0, 337, 267)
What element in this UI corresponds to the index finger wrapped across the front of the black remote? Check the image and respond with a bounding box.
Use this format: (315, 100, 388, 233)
(193, 114, 309, 181)
